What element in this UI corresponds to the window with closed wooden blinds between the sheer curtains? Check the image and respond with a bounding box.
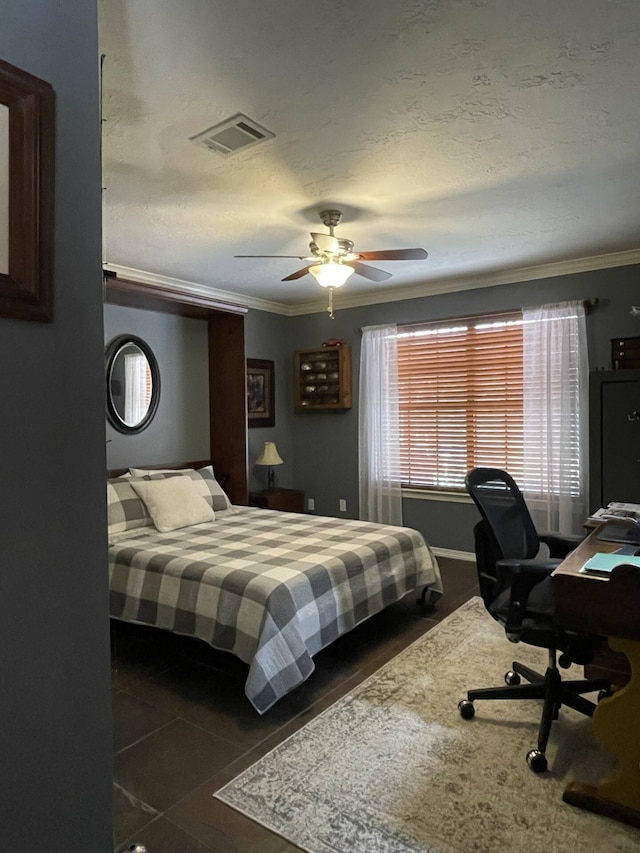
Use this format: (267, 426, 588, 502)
(398, 311, 524, 490)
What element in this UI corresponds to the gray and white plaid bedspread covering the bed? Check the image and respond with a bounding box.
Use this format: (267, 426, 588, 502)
(109, 507, 441, 713)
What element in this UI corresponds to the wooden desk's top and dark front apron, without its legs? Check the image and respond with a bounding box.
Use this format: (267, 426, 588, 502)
(552, 528, 640, 640)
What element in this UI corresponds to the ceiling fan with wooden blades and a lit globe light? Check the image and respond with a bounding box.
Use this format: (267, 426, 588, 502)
(235, 210, 427, 317)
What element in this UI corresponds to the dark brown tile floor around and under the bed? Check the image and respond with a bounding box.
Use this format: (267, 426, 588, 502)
(112, 558, 478, 853)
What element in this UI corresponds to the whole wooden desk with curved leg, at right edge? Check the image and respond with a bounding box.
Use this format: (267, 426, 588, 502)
(552, 530, 640, 826)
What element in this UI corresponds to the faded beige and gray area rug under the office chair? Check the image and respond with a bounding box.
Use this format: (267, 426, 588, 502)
(214, 598, 640, 853)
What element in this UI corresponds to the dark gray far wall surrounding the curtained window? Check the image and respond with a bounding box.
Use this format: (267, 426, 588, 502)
(289, 266, 640, 551)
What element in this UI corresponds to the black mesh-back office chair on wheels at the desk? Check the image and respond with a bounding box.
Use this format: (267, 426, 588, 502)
(458, 468, 610, 773)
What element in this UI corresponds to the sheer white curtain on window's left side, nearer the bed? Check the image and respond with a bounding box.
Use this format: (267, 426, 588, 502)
(358, 326, 402, 525)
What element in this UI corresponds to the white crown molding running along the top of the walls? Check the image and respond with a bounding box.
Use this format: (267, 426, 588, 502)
(103, 249, 640, 317)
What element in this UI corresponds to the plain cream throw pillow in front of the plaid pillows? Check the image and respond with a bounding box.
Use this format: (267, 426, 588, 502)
(131, 477, 216, 533)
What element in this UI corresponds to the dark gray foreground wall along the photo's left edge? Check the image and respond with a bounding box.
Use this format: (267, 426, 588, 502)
(0, 0, 113, 853)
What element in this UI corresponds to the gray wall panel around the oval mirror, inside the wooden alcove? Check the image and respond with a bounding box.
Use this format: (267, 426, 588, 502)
(104, 305, 210, 468)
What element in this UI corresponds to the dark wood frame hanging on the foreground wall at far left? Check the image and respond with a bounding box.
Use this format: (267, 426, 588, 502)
(0, 60, 54, 322)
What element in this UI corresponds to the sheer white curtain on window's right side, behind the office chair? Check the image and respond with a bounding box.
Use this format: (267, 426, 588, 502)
(522, 302, 588, 533)
